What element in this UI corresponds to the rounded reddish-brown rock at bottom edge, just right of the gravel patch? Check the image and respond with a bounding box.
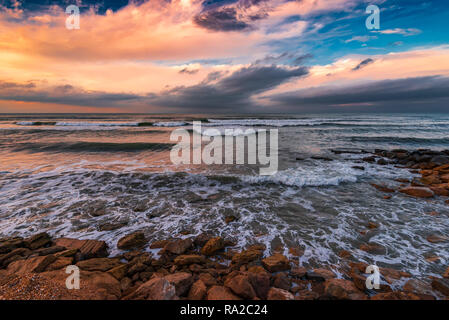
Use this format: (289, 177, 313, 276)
(124, 277, 177, 300)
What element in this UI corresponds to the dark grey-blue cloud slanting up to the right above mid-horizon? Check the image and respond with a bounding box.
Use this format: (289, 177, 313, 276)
(148, 65, 308, 112)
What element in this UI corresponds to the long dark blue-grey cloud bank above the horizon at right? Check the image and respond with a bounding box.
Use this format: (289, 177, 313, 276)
(266, 76, 449, 112)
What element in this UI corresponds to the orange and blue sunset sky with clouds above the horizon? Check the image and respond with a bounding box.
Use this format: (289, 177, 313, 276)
(0, 0, 449, 114)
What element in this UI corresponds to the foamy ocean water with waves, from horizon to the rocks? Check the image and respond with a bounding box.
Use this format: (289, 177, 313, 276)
(0, 114, 449, 284)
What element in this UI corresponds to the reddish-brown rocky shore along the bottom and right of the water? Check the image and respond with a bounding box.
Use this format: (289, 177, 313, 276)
(0, 149, 449, 300)
